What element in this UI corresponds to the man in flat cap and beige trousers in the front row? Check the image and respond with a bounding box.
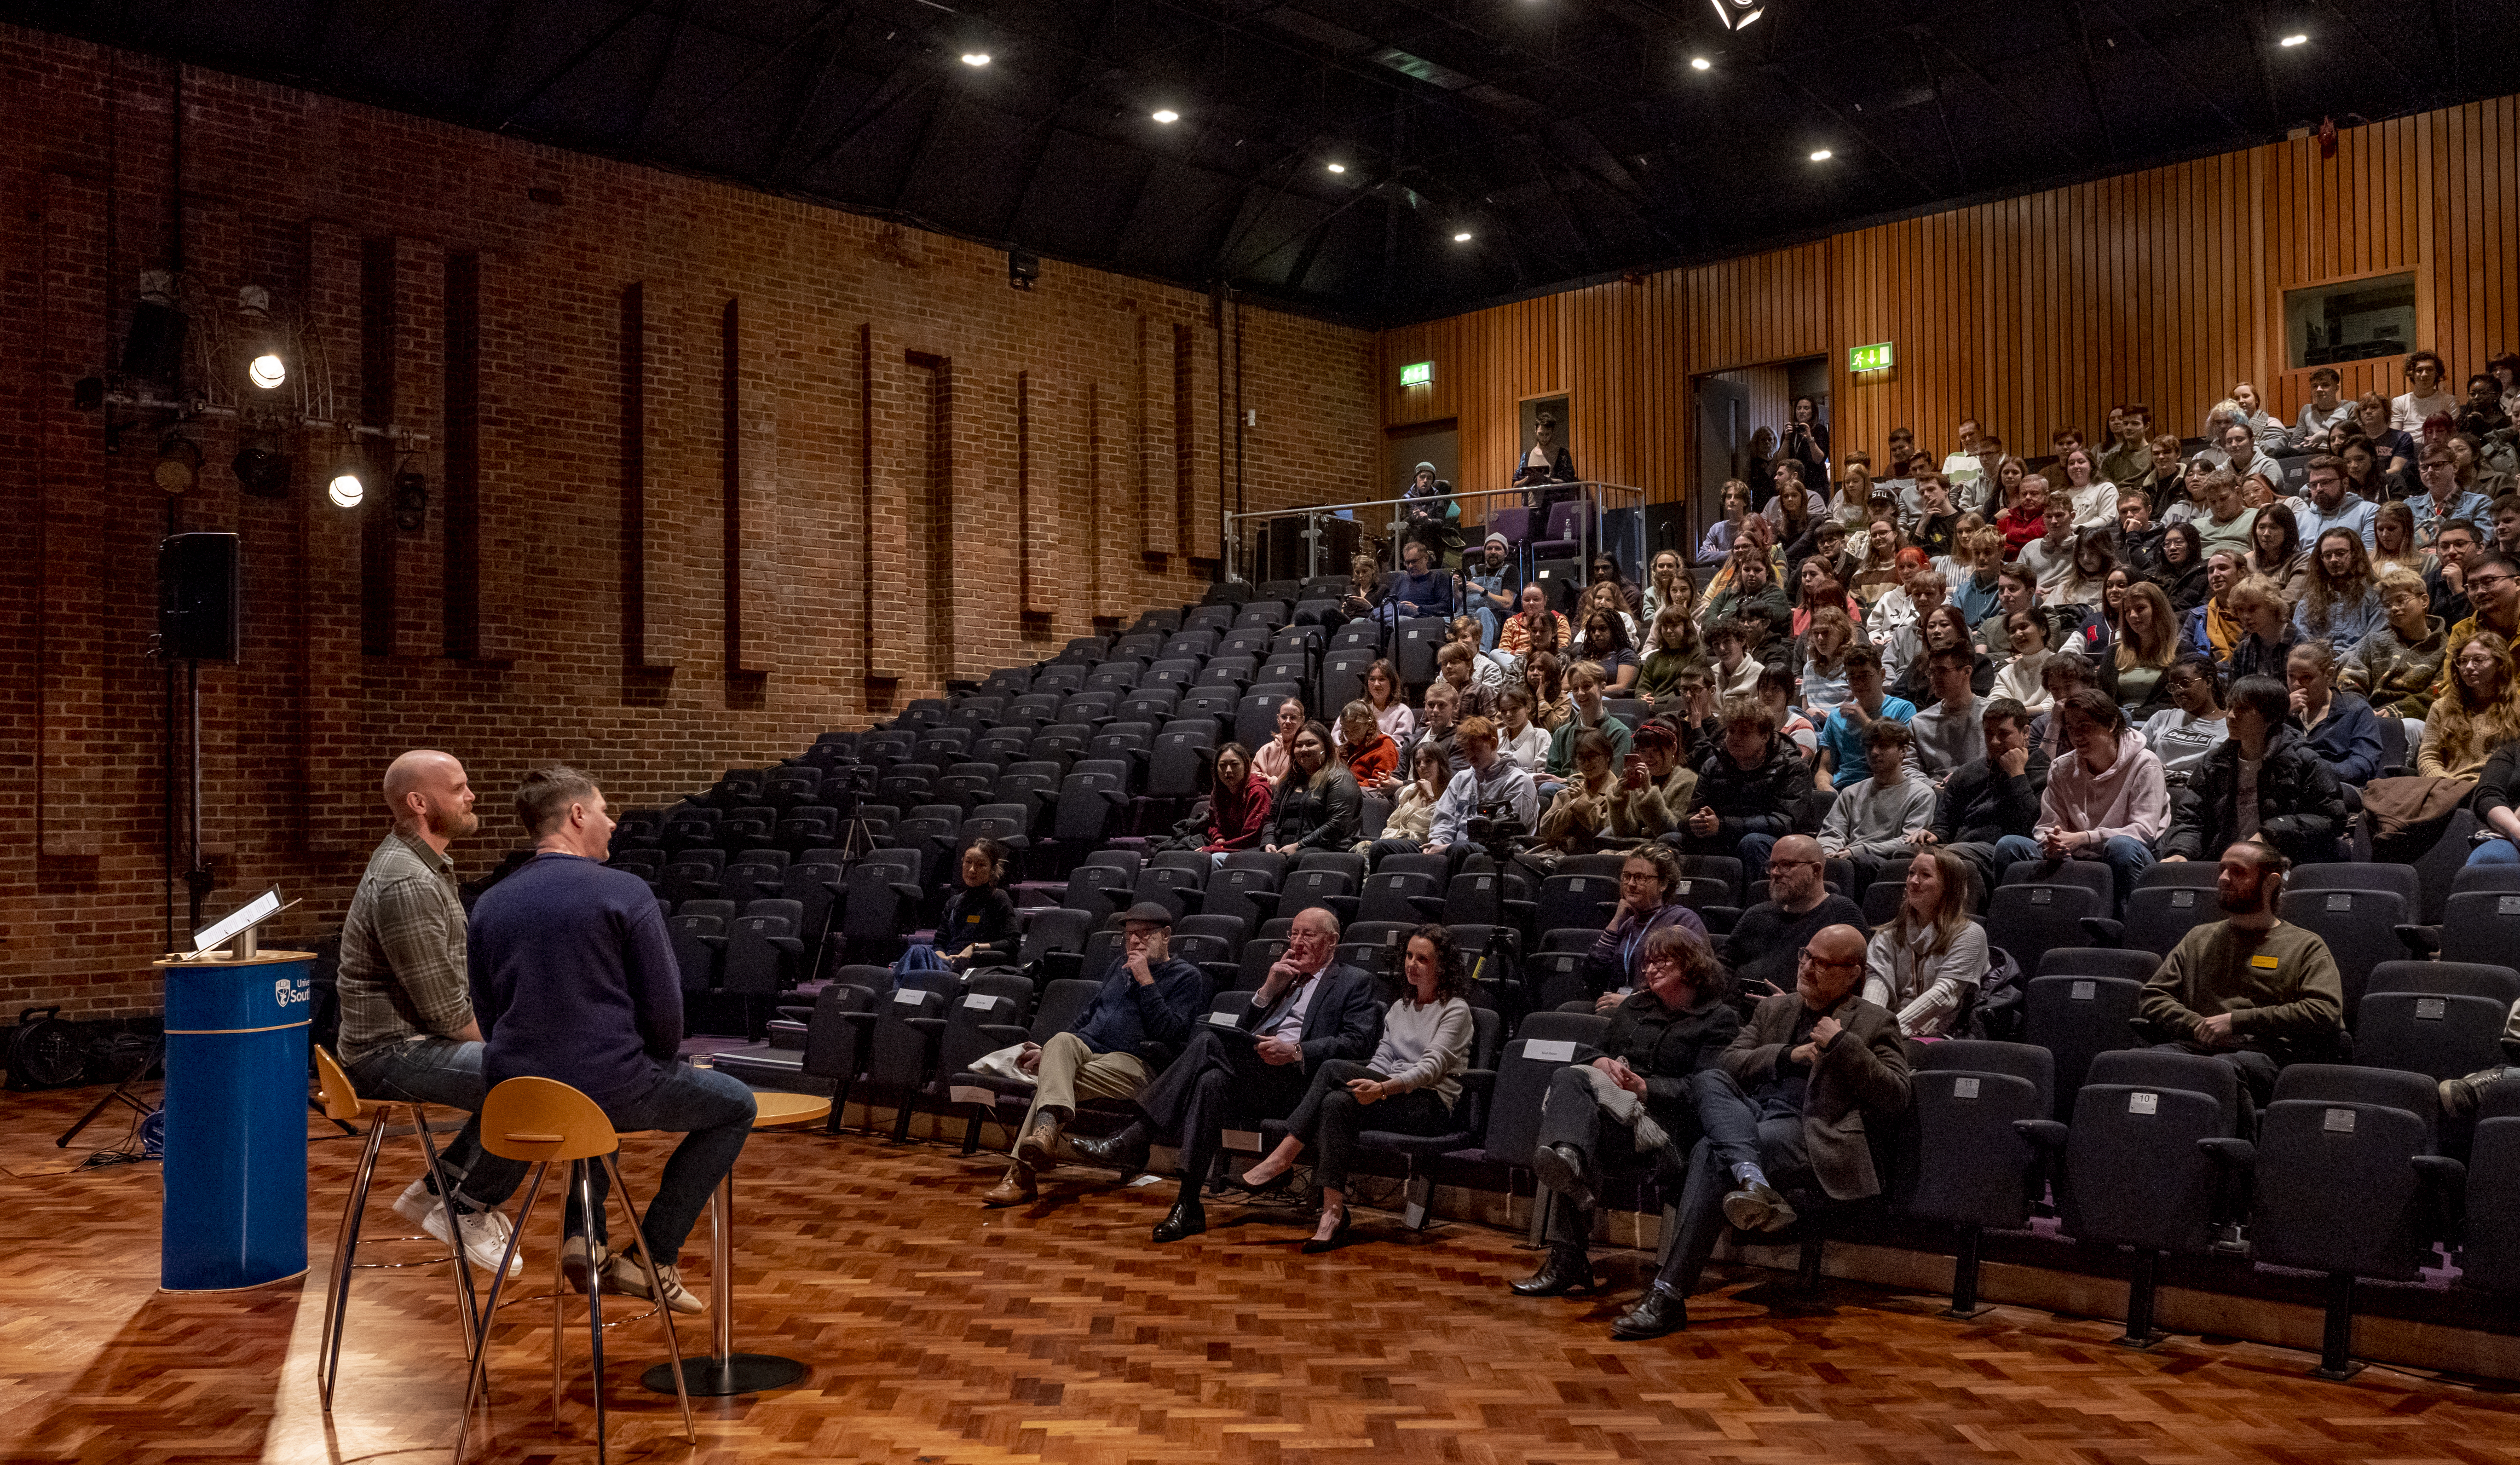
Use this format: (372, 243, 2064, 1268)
(981, 900, 1207, 1206)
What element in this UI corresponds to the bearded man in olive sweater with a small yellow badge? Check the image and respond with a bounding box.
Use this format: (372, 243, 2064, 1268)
(2137, 840, 2344, 1107)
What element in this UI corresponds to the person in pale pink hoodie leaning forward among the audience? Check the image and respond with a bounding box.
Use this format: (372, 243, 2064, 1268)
(1996, 686, 2170, 915)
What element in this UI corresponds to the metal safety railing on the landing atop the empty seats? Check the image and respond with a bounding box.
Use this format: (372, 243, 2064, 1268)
(1225, 479, 1646, 582)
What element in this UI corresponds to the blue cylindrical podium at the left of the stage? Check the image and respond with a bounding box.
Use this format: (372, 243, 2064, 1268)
(156, 950, 315, 1291)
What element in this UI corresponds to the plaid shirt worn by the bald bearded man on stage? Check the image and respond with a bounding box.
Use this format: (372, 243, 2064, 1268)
(338, 832, 471, 1064)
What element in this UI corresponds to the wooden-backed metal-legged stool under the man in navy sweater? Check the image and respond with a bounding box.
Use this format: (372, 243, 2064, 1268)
(454, 1079, 701, 1465)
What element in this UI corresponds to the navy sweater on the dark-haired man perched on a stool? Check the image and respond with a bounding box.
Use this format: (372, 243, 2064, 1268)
(471, 855, 683, 1107)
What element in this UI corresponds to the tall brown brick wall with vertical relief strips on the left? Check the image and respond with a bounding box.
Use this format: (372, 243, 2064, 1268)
(0, 28, 1379, 1021)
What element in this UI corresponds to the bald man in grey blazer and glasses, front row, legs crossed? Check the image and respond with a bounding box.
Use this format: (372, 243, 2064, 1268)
(1610, 925, 1907, 1339)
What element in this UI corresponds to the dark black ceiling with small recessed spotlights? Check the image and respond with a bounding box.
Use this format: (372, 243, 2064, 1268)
(0, 0, 2520, 325)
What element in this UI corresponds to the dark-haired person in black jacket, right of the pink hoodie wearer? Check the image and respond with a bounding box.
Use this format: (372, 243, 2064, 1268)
(2162, 676, 2346, 862)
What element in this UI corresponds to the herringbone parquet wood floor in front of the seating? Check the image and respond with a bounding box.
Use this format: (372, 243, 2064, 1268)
(0, 1079, 2520, 1465)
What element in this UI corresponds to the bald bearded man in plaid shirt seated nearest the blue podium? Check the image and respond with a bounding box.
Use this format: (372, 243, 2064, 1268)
(335, 749, 524, 1276)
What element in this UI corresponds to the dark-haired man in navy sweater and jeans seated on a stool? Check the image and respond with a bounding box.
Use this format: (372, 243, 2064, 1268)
(471, 766, 753, 1314)
